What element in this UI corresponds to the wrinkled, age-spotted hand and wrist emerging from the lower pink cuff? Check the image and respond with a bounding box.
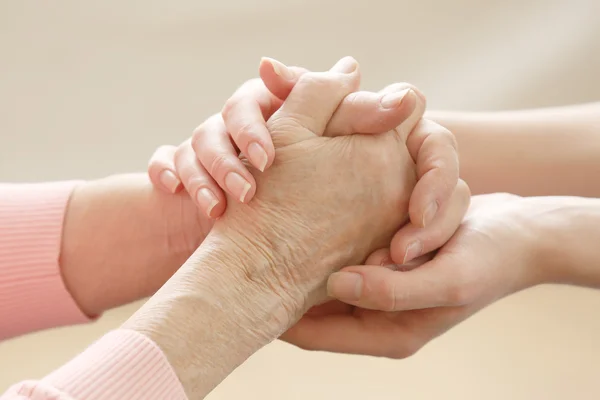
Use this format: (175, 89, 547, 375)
(124, 57, 434, 399)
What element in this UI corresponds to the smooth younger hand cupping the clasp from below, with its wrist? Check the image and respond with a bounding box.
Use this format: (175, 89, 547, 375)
(283, 194, 560, 358)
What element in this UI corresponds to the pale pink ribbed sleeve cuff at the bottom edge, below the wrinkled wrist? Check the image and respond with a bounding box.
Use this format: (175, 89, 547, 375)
(0, 329, 187, 400)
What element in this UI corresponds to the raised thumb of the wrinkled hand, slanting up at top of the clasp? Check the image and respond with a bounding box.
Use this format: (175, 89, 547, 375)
(268, 57, 359, 144)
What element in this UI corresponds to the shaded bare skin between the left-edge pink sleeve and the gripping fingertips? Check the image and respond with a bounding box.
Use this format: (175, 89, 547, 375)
(60, 174, 208, 315)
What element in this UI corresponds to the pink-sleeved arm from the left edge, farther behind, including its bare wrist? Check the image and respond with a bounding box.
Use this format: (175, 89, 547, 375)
(0, 174, 208, 338)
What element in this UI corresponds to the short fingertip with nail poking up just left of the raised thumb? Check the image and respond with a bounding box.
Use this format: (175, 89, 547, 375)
(258, 57, 308, 101)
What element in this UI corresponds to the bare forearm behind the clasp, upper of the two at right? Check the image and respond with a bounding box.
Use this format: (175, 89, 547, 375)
(426, 103, 600, 197)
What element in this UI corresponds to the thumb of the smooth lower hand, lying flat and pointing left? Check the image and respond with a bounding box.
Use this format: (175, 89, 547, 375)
(327, 254, 468, 311)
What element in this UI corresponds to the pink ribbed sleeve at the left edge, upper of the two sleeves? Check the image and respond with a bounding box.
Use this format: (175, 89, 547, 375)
(0, 182, 89, 339)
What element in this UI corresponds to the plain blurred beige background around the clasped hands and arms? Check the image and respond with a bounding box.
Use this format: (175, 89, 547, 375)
(0, 0, 600, 400)
